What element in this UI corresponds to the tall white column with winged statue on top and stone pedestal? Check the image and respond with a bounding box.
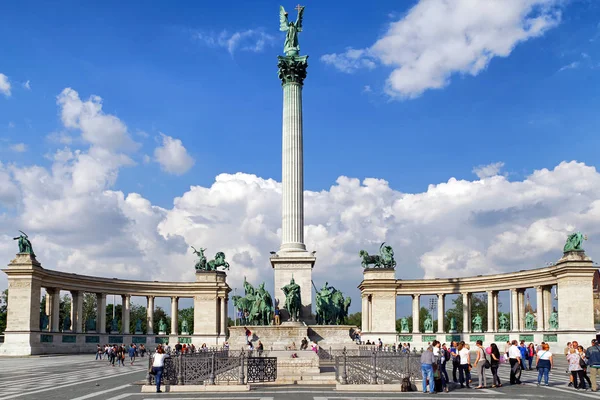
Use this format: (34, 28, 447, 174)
(270, 6, 316, 321)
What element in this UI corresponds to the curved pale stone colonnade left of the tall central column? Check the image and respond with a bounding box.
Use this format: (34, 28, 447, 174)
(0, 253, 231, 355)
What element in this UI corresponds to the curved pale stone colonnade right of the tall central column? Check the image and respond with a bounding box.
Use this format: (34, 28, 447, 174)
(359, 251, 598, 347)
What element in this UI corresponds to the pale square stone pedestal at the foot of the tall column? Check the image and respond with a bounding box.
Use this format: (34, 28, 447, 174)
(270, 252, 316, 323)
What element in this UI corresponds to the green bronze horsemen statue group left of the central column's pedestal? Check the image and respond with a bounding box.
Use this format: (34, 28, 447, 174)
(232, 277, 275, 325)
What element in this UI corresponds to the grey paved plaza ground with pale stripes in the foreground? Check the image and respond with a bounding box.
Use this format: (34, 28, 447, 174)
(0, 355, 600, 400)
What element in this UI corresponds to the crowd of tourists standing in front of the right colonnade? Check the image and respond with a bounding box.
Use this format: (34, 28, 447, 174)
(414, 339, 600, 393)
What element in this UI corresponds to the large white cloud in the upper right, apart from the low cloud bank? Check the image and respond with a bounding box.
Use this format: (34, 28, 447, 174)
(322, 0, 563, 98)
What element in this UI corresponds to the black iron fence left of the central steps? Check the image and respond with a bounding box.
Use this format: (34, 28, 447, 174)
(147, 350, 277, 385)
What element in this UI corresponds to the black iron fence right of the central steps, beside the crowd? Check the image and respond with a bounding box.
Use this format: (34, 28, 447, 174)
(335, 349, 421, 385)
